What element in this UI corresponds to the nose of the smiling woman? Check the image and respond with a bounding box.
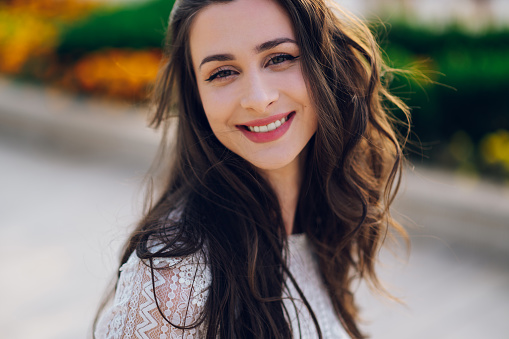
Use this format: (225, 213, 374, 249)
(240, 72, 279, 113)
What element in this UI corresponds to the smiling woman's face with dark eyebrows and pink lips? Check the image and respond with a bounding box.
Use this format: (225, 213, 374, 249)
(189, 0, 317, 170)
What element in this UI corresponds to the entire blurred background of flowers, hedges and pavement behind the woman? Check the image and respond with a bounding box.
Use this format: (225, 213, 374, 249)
(0, 0, 509, 339)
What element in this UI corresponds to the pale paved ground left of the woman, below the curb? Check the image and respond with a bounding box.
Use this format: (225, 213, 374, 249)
(0, 140, 141, 339)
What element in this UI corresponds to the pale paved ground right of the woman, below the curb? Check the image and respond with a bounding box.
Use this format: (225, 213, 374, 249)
(360, 226, 509, 339)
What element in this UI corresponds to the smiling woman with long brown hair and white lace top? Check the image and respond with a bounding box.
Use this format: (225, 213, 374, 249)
(96, 0, 407, 338)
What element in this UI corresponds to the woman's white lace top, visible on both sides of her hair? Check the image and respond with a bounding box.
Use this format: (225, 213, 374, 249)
(95, 235, 350, 339)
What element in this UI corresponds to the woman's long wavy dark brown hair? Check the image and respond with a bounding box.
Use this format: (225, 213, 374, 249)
(98, 0, 408, 338)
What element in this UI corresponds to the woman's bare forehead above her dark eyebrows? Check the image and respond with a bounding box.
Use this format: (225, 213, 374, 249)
(189, 0, 295, 61)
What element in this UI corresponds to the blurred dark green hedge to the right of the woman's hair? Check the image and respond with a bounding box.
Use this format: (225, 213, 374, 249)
(375, 22, 509, 179)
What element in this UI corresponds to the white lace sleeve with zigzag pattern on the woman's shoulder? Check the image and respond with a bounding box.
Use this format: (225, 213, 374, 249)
(95, 253, 211, 339)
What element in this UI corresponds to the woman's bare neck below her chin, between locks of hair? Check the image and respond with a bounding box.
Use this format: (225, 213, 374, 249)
(262, 155, 302, 235)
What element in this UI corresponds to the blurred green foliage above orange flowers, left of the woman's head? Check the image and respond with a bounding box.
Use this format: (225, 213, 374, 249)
(57, 0, 175, 56)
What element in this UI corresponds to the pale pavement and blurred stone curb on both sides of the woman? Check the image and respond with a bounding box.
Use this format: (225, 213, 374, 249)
(0, 80, 509, 339)
